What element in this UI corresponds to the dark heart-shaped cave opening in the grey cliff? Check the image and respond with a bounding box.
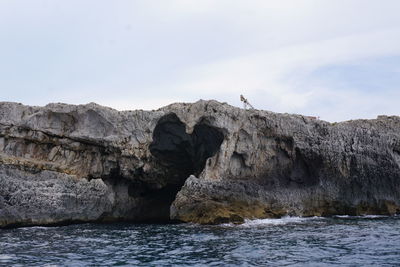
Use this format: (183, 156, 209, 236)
(145, 113, 224, 223)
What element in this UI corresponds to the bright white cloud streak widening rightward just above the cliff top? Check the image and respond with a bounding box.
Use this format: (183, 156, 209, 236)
(162, 30, 400, 120)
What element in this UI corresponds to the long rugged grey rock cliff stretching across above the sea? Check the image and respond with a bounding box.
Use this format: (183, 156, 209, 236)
(0, 100, 400, 226)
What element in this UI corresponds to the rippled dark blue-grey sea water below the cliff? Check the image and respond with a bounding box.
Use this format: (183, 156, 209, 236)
(0, 217, 400, 266)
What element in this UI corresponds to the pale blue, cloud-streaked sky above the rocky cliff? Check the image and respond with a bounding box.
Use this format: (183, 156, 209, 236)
(0, 0, 400, 122)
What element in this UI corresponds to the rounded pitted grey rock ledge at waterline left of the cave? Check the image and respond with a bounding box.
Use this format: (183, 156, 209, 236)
(0, 165, 114, 225)
